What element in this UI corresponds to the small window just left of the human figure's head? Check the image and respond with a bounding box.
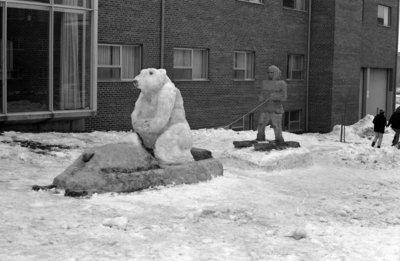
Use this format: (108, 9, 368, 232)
(233, 51, 254, 80)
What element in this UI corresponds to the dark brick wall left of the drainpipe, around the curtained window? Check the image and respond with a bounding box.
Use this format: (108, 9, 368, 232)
(85, 0, 161, 131)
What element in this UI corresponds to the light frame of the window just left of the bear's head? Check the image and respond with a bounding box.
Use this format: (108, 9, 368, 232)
(97, 43, 142, 82)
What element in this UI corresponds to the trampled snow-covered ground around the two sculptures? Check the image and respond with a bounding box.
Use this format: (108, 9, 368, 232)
(0, 116, 400, 261)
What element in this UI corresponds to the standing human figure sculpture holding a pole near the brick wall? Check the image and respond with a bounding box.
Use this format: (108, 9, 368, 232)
(257, 65, 287, 143)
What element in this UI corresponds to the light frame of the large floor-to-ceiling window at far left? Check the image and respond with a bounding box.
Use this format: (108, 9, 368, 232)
(0, 0, 98, 119)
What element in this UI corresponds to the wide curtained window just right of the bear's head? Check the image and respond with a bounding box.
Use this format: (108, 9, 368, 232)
(174, 48, 208, 80)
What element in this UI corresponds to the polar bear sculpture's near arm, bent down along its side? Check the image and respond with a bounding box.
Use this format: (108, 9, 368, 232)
(149, 82, 176, 132)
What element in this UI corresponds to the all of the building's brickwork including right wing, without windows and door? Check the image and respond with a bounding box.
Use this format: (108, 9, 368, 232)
(85, 0, 398, 132)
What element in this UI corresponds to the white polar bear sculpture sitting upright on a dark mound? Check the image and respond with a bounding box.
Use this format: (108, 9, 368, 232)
(131, 68, 193, 164)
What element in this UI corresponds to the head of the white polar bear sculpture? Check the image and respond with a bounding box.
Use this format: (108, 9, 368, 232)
(133, 68, 171, 94)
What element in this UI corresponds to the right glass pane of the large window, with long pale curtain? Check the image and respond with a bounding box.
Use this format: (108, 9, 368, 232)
(53, 11, 90, 110)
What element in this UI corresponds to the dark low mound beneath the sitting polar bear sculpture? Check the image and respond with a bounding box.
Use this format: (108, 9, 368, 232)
(53, 144, 223, 195)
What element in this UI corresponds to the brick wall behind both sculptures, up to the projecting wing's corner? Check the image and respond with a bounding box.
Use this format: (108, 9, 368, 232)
(86, 0, 308, 130)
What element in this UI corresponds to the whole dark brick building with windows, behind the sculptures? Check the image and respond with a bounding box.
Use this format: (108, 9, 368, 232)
(0, 0, 399, 132)
